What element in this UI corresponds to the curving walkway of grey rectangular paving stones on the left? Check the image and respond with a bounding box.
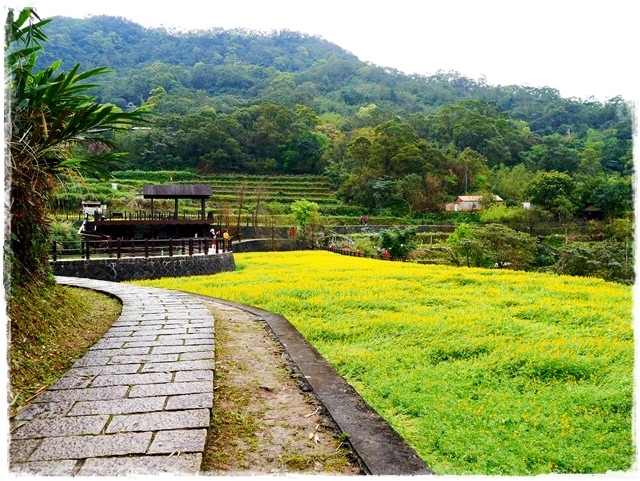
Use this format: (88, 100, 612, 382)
(9, 277, 215, 476)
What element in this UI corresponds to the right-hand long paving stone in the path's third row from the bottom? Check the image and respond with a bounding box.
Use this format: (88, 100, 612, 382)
(106, 409, 210, 434)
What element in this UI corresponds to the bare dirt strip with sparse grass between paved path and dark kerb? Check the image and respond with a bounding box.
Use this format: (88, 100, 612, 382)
(203, 301, 364, 475)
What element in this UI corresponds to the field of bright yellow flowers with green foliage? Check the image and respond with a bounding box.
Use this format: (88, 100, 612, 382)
(138, 251, 636, 475)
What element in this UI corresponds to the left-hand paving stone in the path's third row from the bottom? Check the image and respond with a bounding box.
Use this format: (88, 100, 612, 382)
(11, 416, 109, 439)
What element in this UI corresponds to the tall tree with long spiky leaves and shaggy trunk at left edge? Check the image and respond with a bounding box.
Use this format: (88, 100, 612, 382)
(5, 8, 146, 287)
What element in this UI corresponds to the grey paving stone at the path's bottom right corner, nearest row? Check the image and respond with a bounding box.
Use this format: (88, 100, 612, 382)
(78, 453, 202, 476)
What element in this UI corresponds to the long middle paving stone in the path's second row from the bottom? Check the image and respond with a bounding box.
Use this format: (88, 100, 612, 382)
(29, 432, 152, 461)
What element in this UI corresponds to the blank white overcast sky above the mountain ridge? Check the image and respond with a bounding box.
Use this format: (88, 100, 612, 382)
(4, 0, 640, 101)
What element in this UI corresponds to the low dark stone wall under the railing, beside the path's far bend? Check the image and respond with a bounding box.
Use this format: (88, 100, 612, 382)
(52, 252, 236, 282)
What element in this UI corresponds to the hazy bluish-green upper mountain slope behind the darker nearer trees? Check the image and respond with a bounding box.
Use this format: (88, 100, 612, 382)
(41, 16, 622, 135)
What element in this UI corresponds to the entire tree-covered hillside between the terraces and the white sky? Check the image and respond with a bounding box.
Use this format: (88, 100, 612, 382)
(39, 16, 633, 217)
